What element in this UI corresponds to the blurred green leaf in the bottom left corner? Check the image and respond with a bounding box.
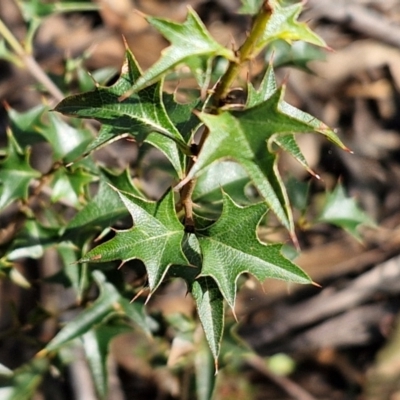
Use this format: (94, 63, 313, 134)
(0, 358, 49, 400)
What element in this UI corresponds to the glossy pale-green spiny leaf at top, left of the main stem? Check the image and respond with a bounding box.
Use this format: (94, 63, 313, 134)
(126, 7, 235, 91)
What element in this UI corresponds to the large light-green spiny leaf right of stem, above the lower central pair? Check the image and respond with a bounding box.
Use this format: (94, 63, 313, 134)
(188, 87, 344, 232)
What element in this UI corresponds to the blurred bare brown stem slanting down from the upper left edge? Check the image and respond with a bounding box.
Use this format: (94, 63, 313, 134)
(0, 18, 64, 101)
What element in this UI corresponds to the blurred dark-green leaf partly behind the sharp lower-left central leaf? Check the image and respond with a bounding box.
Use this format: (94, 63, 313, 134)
(63, 169, 143, 243)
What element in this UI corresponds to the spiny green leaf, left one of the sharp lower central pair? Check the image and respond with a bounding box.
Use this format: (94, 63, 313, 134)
(81, 191, 189, 292)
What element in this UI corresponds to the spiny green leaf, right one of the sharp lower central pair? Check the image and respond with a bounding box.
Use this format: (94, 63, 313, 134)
(197, 194, 311, 308)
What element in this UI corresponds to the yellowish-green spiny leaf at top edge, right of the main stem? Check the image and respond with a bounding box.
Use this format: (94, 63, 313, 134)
(256, 0, 326, 50)
